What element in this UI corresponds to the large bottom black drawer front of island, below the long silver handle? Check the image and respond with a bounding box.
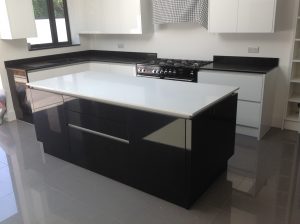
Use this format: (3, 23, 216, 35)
(69, 124, 129, 183)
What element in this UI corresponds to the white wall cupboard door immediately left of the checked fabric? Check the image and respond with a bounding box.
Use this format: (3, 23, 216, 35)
(117, 0, 142, 34)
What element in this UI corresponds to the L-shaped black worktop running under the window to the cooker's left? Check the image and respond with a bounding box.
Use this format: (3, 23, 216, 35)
(5, 50, 157, 71)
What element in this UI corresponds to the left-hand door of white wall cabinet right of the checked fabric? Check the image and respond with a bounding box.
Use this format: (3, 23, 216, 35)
(208, 0, 238, 33)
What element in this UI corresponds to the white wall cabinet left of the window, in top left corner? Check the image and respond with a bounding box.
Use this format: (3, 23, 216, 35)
(0, 0, 37, 40)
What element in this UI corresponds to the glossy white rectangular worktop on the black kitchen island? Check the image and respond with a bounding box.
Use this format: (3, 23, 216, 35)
(28, 71, 238, 118)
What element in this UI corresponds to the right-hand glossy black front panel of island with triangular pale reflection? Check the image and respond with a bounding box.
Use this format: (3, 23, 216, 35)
(129, 111, 186, 206)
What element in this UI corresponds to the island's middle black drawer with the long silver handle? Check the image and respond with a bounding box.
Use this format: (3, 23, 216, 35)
(65, 111, 129, 142)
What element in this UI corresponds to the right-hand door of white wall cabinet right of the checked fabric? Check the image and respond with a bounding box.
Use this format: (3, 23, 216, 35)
(237, 0, 276, 33)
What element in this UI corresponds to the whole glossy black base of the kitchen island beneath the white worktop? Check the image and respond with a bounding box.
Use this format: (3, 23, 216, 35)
(31, 89, 237, 208)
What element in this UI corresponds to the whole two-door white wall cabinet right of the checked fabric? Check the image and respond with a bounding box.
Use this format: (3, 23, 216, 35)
(208, 0, 277, 33)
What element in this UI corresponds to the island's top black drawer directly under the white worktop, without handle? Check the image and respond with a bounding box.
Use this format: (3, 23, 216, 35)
(64, 96, 129, 123)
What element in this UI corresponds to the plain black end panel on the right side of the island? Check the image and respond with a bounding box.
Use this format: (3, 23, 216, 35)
(187, 94, 237, 206)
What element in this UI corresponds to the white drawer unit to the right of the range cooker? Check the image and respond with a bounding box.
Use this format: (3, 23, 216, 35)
(198, 70, 275, 139)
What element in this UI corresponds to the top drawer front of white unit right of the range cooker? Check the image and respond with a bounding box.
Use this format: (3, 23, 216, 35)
(198, 71, 264, 102)
